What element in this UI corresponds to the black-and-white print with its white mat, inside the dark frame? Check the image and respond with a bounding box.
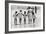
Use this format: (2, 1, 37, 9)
(9, 3, 43, 31)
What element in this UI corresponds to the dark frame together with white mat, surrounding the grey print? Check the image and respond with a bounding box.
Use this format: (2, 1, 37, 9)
(5, 1, 45, 33)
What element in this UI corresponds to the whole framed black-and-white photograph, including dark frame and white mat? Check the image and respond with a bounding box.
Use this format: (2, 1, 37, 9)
(6, 1, 44, 32)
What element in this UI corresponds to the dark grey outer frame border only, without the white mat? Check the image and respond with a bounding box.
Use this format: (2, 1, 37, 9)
(5, 1, 45, 33)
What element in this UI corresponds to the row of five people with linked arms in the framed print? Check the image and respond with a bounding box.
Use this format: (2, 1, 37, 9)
(13, 6, 36, 25)
